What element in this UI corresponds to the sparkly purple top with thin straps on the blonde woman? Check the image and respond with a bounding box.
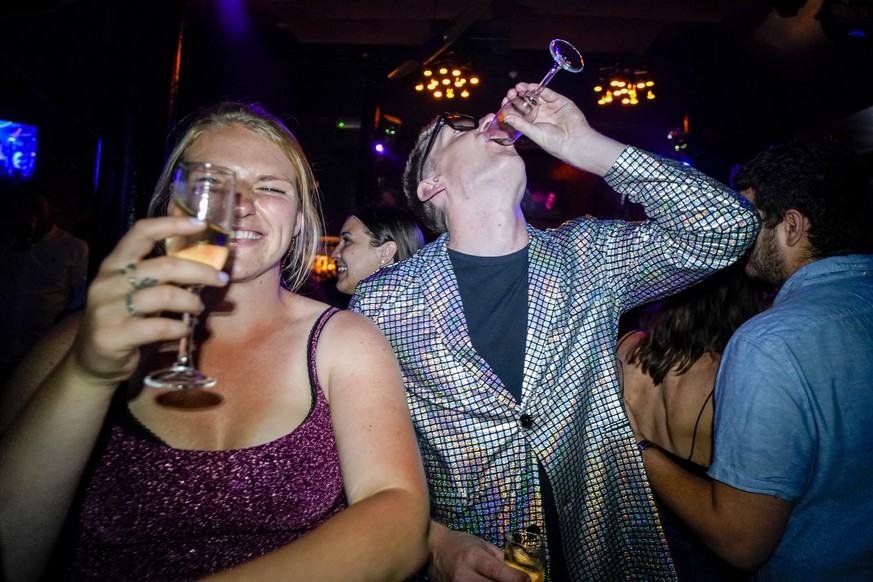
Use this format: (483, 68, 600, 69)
(72, 309, 347, 580)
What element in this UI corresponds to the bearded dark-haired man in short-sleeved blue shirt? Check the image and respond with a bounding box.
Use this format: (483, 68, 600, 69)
(639, 139, 873, 580)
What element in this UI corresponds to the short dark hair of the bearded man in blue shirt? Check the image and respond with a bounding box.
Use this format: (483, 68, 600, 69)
(732, 138, 873, 259)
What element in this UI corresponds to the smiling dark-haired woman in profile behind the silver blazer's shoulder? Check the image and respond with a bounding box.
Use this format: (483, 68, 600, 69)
(330, 204, 424, 295)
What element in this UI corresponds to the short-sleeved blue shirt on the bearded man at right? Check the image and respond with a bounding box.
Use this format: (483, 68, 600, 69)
(709, 255, 873, 581)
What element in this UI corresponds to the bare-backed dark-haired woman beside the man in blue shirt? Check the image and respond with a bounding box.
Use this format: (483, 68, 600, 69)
(617, 261, 768, 581)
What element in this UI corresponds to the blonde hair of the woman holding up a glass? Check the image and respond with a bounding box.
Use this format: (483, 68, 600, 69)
(149, 102, 324, 291)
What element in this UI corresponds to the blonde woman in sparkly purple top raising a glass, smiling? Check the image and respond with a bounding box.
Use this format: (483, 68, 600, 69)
(0, 103, 428, 581)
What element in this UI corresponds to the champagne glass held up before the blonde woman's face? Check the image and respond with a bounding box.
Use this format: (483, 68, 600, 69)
(145, 162, 236, 389)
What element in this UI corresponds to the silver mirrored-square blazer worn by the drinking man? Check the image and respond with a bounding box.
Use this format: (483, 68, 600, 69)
(350, 147, 758, 581)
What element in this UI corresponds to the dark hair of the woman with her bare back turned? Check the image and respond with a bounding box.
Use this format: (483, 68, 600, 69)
(628, 261, 768, 385)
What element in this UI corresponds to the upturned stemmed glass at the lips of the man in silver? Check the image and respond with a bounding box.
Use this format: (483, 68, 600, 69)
(485, 38, 585, 146)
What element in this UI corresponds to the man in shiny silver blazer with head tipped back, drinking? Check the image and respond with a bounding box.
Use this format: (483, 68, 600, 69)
(350, 83, 758, 581)
